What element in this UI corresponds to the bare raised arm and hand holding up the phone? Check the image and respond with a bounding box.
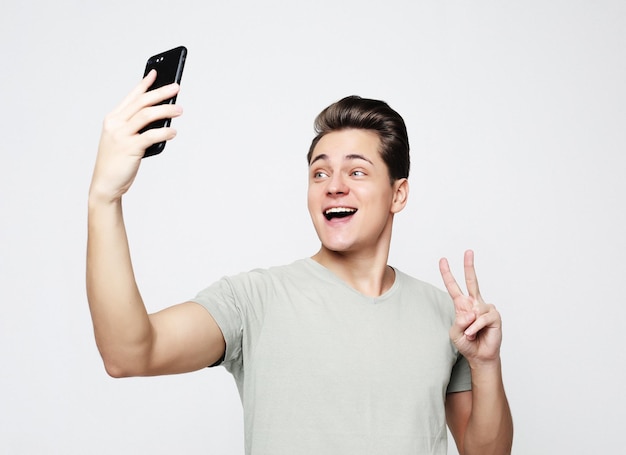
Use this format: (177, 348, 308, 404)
(87, 71, 224, 377)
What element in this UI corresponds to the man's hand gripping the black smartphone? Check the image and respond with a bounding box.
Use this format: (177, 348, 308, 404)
(90, 70, 182, 202)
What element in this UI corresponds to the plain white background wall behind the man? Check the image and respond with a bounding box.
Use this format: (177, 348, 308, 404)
(0, 0, 626, 454)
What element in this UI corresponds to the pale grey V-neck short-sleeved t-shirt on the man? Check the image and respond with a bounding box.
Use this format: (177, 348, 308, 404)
(193, 258, 471, 455)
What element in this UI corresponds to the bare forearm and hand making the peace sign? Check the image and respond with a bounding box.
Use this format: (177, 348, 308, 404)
(439, 251, 513, 455)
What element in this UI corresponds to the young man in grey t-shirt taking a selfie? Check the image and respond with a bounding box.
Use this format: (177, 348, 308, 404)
(87, 69, 512, 455)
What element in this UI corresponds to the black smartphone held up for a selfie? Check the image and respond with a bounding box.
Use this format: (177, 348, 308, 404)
(139, 46, 187, 158)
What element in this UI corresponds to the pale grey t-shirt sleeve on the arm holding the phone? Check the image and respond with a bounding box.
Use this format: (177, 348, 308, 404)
(191, 278, 243, 363)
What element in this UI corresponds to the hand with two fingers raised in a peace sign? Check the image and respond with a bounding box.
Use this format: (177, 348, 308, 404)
(439, 250, 502, 367)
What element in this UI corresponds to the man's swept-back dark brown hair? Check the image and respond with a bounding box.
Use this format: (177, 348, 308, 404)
(307, 96, 410, 183)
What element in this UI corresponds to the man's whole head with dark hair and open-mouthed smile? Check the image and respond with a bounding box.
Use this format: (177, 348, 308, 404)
(307, 96, 409, 260)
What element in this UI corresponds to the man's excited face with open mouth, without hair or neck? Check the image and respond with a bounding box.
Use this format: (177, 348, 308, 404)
(308, 129, 407, 254)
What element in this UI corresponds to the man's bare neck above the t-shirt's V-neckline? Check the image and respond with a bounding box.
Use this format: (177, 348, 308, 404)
(312, 246, 396, 297)
